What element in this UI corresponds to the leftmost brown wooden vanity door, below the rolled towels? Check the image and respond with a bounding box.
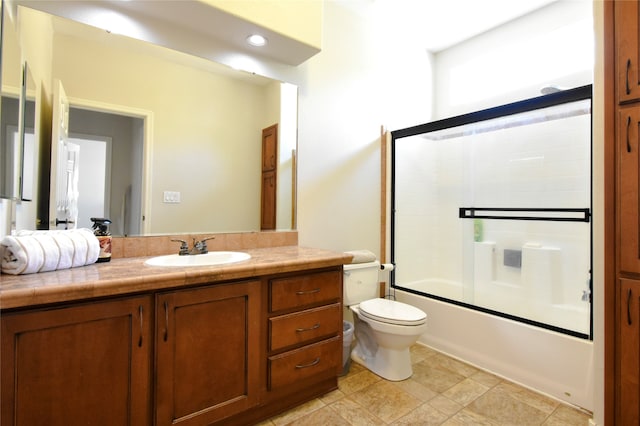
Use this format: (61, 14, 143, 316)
(0, 296, 153, 426)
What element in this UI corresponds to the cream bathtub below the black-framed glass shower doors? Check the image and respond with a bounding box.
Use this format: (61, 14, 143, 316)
(395, 288, 595, 411)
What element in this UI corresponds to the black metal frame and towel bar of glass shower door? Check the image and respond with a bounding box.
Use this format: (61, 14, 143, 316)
(390, 85, 593, 340)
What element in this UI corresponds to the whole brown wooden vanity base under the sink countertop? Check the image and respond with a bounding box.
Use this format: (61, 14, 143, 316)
(0, 266, 342, 426)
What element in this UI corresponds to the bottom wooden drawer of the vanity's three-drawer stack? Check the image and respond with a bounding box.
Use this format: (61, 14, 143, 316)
(268, 336, 342, 390)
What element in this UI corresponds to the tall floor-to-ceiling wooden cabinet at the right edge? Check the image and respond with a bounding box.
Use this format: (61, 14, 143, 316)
(616, 1, 640, 425)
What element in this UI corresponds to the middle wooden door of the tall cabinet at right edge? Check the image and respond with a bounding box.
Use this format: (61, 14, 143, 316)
(617, 105, 640, 273)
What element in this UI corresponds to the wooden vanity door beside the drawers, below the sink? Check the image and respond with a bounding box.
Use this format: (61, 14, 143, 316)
(156, 281, 261, 426)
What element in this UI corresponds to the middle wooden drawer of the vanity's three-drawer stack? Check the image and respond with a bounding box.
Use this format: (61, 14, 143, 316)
(269, 303, 342, 351)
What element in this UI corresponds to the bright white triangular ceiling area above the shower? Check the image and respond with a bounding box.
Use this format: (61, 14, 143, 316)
(370, 0, 560, 53)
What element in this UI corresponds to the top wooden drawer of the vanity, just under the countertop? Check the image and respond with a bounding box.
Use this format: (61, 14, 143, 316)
(270, 269, 342, 312)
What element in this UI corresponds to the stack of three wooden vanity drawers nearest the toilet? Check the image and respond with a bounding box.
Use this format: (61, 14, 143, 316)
(267, 268, 342, 396)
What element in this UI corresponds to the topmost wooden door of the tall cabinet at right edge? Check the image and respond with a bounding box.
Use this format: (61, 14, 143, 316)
(614, 1, 640, 102)
